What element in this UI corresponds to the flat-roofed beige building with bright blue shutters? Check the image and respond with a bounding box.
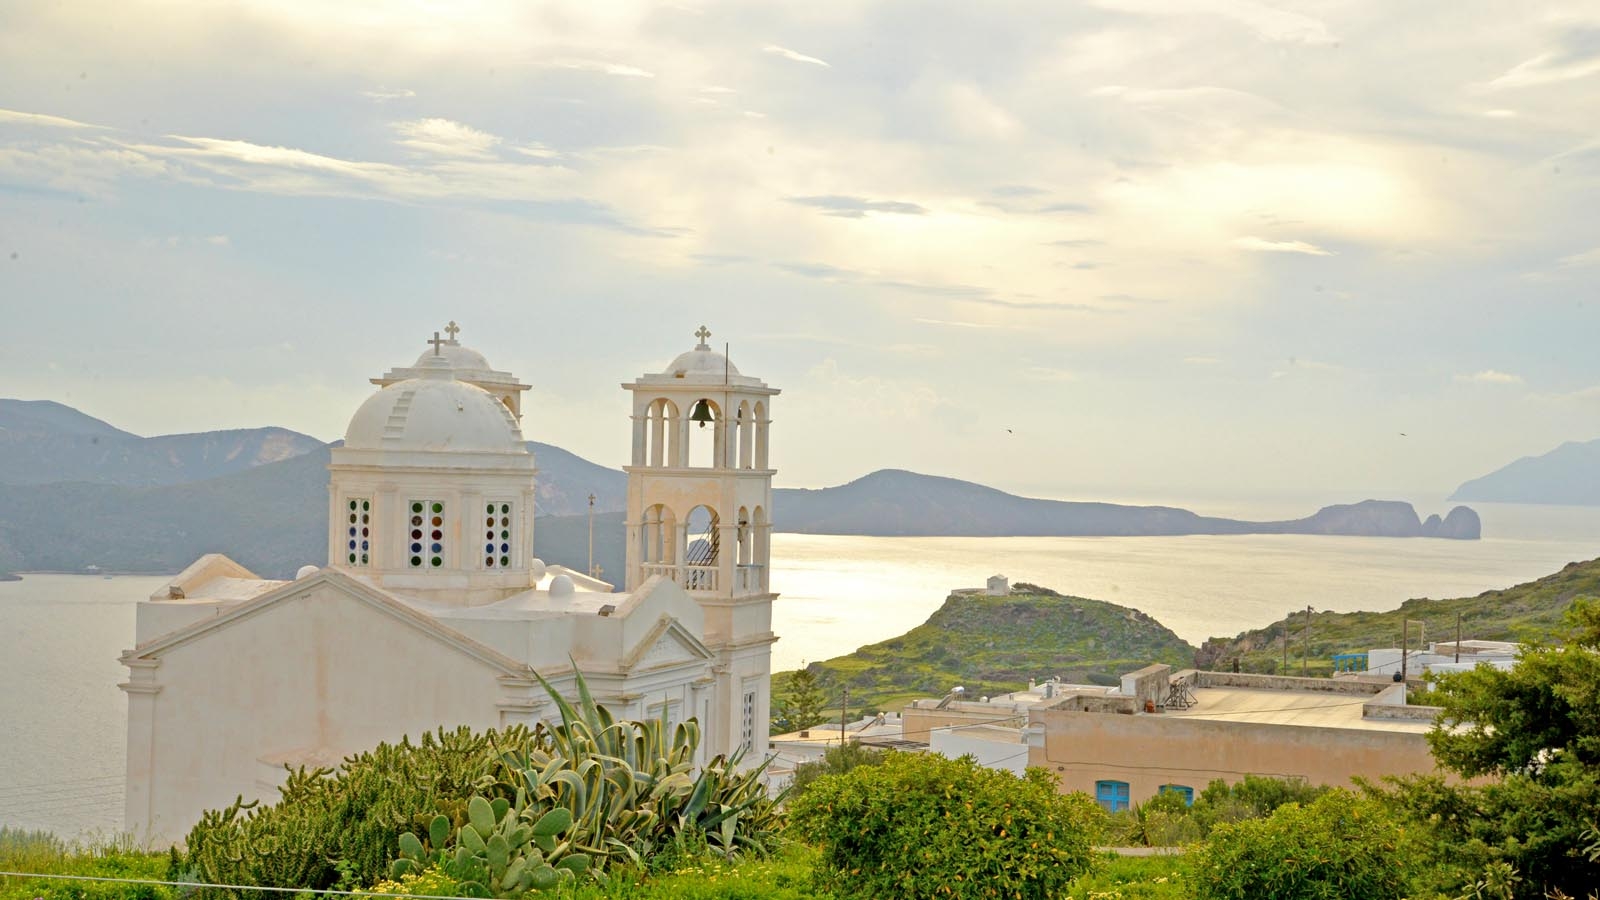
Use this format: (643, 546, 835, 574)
(904, 666, 1438, 810)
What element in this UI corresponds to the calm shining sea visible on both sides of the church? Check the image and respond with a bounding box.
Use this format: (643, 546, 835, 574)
(0, 503, 1600, 839)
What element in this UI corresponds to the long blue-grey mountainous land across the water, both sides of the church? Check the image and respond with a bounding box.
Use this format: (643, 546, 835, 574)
(0, 400, 1482, 578)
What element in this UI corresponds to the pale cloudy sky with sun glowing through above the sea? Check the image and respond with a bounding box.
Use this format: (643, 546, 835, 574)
(0, 0, 1600, 512)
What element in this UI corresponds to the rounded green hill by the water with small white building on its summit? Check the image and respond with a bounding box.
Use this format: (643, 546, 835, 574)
(773, 585, 1195, 714)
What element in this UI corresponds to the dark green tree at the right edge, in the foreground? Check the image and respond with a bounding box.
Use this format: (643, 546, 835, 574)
(1389, 599, 1600, 898)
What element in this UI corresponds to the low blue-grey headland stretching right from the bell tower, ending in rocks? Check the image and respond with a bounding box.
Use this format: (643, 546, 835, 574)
(773, 469, 1478, 540)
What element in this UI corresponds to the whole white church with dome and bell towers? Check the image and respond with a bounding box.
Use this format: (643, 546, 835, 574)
(122, 322, 778, 842)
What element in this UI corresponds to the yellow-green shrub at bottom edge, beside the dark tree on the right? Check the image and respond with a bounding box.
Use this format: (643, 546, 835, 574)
(1187, 790, 1426, 900)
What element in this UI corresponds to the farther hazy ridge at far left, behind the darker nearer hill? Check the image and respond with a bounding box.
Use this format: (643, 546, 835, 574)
(0, 400, 322, 487)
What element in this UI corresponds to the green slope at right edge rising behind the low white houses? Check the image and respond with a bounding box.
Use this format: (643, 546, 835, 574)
(1195, 559, 1600, 674)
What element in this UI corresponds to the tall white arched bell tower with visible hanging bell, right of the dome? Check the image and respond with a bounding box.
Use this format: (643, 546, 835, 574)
(622, 325, 778, 764)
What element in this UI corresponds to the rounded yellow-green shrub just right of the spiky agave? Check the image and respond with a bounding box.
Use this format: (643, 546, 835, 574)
(790, 753, 1094, 900)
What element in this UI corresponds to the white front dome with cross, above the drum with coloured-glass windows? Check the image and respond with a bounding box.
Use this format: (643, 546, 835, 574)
(344, 366, 526, 453)
